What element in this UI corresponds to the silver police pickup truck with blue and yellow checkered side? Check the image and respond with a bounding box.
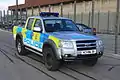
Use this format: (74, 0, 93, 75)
(13, 12, 104, 71)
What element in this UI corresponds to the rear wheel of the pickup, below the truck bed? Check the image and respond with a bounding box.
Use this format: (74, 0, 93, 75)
(16, 38, 26, 55)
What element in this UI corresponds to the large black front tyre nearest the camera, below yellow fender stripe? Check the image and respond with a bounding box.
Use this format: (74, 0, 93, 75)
(43, 47, 61, 71)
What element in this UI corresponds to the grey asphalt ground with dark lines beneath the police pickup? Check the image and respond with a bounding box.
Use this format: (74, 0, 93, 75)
(0, 30, 120, 80)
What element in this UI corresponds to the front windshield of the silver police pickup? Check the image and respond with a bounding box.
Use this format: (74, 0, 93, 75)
(44, 19, 78, 32)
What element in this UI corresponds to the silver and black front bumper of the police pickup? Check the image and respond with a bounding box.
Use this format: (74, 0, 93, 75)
(62, 49, 104, 61)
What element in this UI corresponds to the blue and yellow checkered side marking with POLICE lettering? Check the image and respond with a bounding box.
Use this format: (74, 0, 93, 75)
(13, 26, 60, 48)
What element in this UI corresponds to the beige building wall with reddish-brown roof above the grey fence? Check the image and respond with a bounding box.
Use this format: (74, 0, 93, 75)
(8, 0, 116, 16)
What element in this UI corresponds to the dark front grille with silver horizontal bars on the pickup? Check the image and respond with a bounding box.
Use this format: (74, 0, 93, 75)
(76, 40, 96, 51)
